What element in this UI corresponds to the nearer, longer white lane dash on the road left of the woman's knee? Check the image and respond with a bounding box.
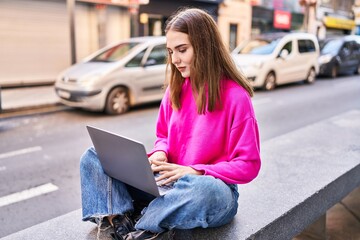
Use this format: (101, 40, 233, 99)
(0, 183, 59, 207)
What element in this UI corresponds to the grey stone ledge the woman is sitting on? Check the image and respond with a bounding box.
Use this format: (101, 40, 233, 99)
(3, 110, 360, 240)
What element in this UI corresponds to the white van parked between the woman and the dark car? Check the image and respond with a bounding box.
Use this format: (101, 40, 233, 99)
(232, 33, 319, 90)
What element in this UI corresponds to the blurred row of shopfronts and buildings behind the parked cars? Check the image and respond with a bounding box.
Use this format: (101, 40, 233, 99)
(0, 0, 360, 87)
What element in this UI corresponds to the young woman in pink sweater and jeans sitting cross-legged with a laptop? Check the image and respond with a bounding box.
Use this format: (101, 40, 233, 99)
(81, 9, 260, 239)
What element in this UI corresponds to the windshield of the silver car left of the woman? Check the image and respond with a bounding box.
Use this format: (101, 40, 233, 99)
(90, 42, 139, 62)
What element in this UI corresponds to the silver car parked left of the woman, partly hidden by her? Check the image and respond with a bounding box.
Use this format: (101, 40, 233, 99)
(55, 37, 167, 114)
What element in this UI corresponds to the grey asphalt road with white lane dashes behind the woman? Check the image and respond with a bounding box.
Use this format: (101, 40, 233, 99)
(0, 75, 360, 238)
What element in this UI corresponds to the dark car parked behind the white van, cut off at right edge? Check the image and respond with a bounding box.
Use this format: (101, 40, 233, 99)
(319, 35, 360, 78)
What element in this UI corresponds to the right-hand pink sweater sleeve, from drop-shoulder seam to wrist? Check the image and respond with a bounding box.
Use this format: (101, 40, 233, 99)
(191, 118, 261, 184)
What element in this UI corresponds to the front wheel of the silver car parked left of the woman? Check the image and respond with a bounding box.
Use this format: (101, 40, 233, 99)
(105, 87, 130, 115)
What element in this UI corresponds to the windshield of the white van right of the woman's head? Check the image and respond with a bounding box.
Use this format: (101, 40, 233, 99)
(239, 39, 280, 55)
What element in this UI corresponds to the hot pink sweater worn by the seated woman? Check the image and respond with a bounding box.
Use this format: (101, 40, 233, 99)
(149, 79, 261, 184)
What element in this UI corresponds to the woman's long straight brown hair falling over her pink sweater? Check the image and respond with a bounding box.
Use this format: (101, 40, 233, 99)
(165, 8, 254, 114)
